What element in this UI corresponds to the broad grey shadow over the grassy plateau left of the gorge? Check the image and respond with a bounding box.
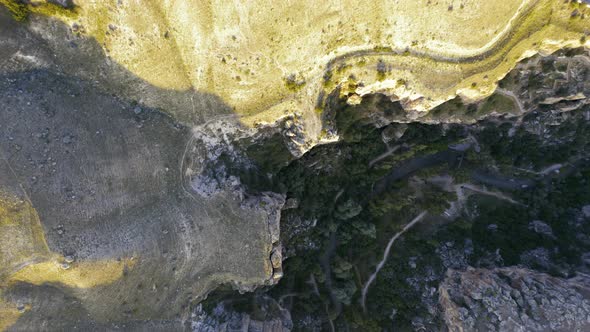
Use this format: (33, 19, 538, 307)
(0, 6, 268, 331)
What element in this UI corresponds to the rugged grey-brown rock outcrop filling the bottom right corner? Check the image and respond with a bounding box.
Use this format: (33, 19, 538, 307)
(439, 267, 590, 332)
